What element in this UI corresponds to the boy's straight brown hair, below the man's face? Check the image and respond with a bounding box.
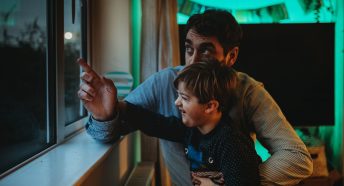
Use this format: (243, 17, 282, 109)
(173, 60, 237, 112)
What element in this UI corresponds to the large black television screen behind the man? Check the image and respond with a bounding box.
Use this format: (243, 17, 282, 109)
(180, 23, 334, 126)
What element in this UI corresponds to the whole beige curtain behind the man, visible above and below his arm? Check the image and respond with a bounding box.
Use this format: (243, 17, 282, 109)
(140, 0, 180, 185)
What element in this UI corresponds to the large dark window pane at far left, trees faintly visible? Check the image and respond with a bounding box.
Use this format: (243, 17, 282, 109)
(0, 0, 54, 174)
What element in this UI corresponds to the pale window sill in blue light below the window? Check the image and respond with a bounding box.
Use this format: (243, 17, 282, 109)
(0, 131, 117, 186)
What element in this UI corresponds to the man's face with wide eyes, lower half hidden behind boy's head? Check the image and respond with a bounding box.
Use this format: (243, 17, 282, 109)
(185, 29, 225, 65)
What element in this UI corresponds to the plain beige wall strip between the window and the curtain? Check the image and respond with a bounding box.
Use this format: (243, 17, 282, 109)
(91, 0, 131, 74)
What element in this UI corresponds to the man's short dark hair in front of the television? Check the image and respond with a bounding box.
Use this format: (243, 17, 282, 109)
(185, 10, 243, 55)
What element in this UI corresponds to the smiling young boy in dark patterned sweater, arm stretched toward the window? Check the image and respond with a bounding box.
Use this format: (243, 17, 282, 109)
(120, 61, 261, 186)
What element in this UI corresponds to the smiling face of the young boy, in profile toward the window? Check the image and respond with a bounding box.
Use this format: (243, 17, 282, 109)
(175, 81, 207, 127)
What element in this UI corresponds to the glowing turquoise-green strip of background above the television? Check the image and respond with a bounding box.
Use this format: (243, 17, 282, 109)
(177, 0, 338, 24)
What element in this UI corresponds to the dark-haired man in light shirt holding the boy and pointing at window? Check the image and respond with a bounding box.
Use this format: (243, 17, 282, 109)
(78, 10, 313, 185)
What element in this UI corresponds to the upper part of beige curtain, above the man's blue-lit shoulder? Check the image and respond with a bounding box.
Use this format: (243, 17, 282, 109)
(140, 0, 180, 81)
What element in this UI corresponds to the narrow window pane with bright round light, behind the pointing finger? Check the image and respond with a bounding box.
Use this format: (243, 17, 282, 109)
(64, 0, 85, 125)
